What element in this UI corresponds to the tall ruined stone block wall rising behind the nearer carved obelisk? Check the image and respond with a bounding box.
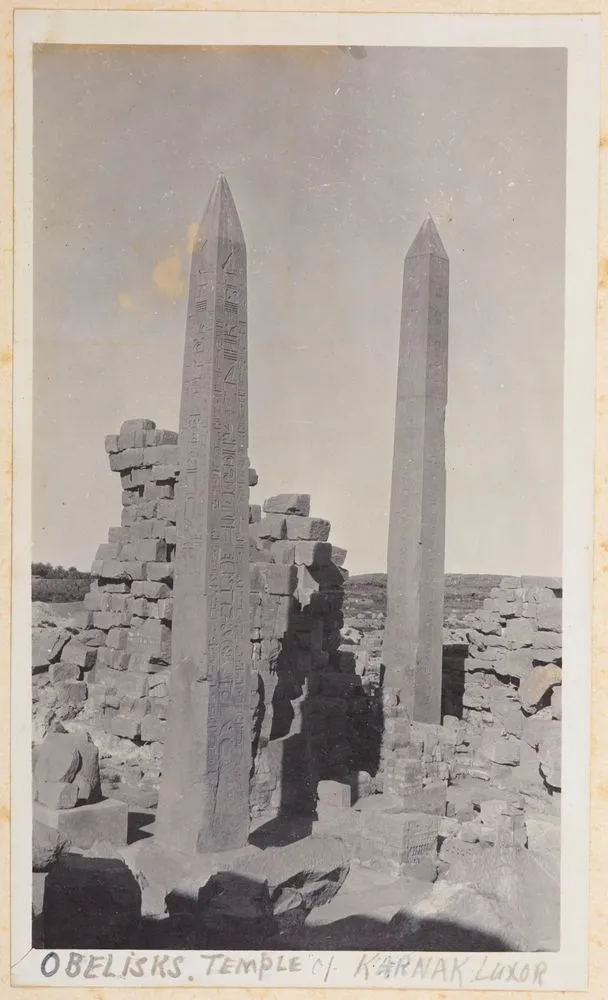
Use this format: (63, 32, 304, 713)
(41, 420, 360, 815)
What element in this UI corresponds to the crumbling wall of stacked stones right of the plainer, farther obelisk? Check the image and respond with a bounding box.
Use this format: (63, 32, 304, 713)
(462, 577, 562, 808)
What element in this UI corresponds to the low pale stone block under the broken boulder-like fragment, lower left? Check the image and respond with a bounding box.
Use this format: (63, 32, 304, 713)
(34, 799, 129, 850)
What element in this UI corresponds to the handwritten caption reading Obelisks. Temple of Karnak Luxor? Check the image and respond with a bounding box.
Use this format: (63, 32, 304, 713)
(40, 951, 547, 989)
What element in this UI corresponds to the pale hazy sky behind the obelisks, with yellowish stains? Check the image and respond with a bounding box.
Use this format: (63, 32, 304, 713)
(32, 45, 566, 575)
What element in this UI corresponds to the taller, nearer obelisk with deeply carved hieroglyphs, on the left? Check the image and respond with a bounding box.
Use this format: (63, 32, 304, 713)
(155, 176, 251, 854)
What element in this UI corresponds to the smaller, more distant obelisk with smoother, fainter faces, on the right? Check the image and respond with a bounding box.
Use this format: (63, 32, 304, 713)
(383, 216, 449, 723)
